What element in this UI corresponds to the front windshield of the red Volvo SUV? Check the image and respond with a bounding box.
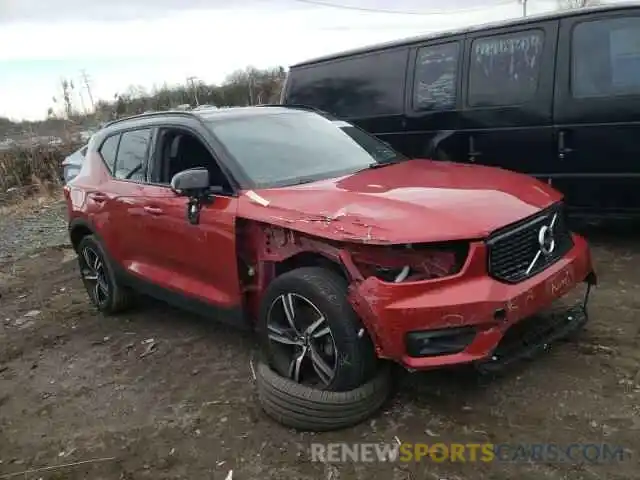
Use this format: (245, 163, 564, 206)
(210, 111, 404, 188)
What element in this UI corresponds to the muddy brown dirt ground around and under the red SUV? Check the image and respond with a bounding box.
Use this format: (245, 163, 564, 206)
(0, 202, 640, 480)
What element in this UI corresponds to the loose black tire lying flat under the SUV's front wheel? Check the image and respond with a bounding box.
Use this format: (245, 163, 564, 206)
(256, 362, 391, 432)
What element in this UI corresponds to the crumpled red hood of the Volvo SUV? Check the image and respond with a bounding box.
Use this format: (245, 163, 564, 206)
(238, 160, 562, 244)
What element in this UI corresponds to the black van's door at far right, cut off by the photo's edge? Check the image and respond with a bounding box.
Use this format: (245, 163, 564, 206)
(554, 9, 640, 213)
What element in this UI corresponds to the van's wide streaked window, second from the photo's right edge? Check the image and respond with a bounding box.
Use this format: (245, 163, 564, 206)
(467, 30, 544, 107)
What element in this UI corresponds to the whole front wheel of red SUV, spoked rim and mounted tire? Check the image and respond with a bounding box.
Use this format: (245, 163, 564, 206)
(258, 267, 377, 391)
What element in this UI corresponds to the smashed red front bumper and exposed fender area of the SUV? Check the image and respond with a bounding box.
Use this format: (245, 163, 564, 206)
(238, 215, 595, 370)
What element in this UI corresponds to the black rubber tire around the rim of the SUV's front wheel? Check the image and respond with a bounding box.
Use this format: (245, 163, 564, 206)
(257, 267, 378, 391)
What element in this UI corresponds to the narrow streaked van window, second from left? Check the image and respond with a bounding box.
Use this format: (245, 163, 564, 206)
(413, 42, 460, 111)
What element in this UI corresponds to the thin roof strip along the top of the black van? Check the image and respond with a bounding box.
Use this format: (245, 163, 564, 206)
(290, 2, 640, 68)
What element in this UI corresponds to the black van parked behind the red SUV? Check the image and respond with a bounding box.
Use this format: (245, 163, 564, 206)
(281, 4, 640, 217)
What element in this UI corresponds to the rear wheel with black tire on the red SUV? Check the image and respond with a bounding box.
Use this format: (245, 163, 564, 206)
(78, 235, 133, 315)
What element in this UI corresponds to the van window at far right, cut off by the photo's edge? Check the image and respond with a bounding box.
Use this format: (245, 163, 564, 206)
(571, 17, 640, 98)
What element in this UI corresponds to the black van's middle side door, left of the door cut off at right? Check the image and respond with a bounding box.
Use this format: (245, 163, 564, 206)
(460, 20, 558, 177)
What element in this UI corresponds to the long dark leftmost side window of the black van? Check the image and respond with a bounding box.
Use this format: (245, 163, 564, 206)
(284, 49, 409, 118)
